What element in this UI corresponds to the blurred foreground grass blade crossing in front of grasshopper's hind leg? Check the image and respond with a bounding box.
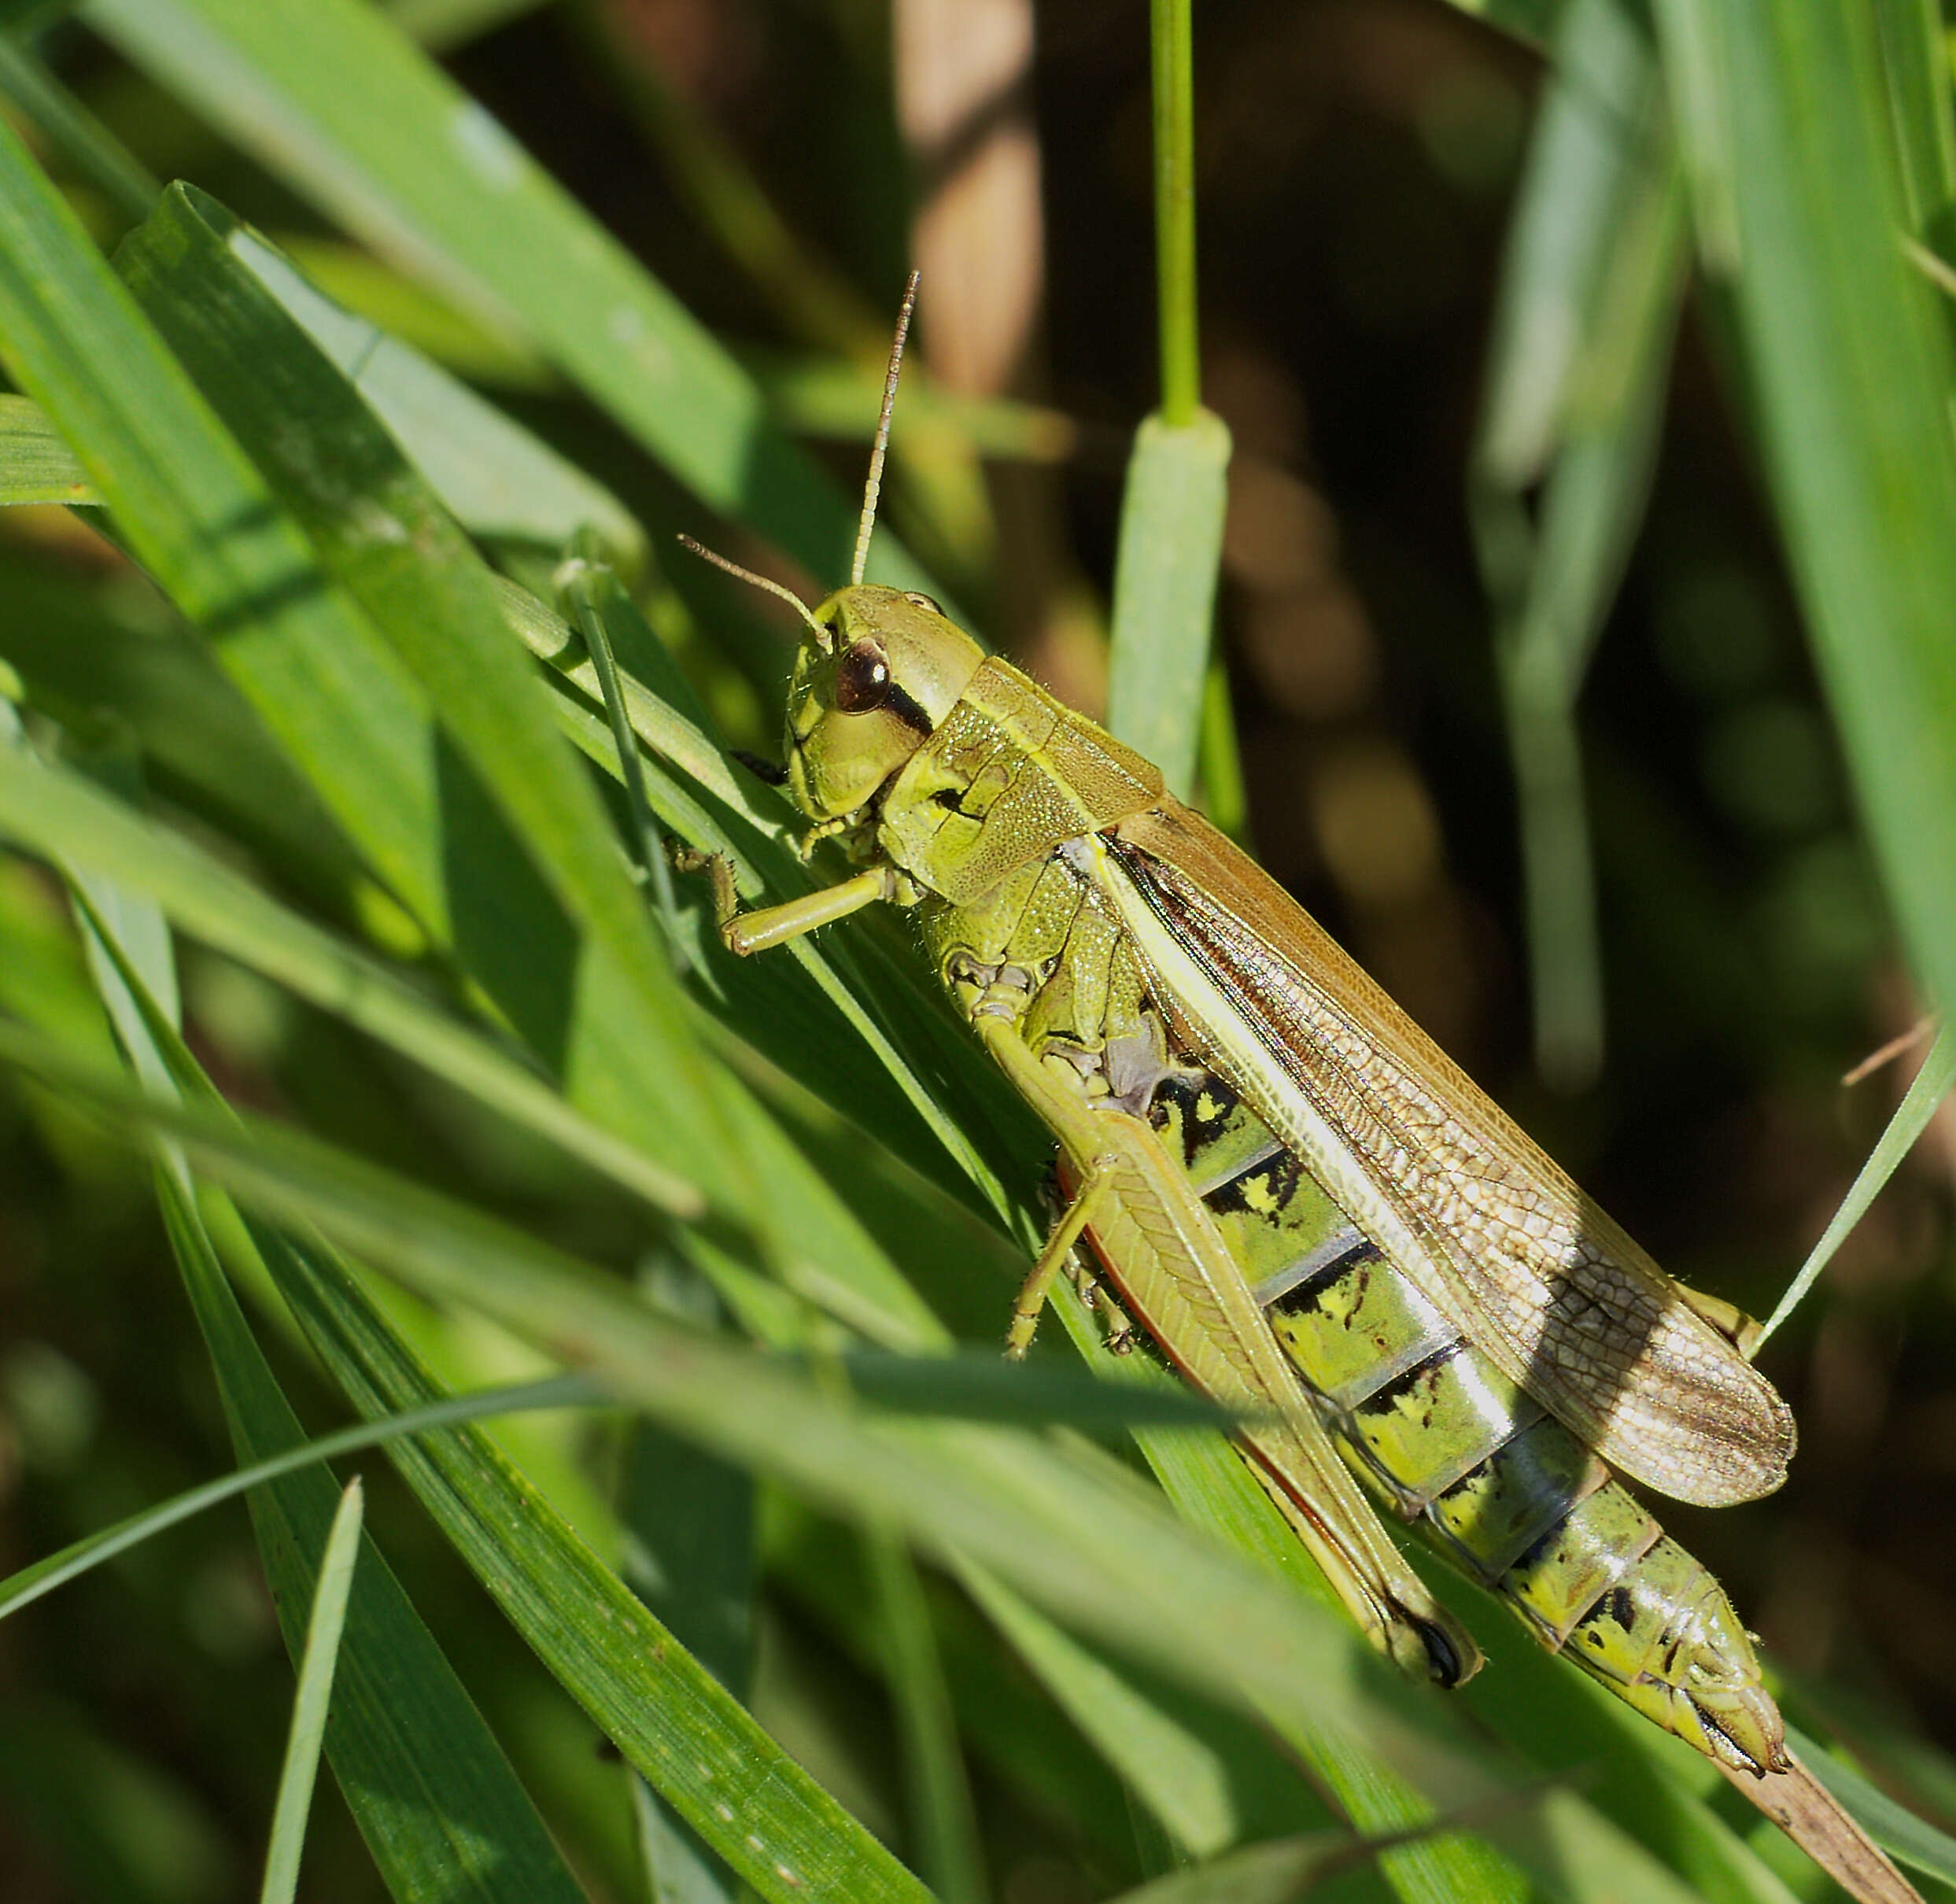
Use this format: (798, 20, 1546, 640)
(0, 1024, 1489, 1795)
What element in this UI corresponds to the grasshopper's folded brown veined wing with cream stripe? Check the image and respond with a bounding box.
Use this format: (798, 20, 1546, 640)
(1103, 800, 1794, 1507)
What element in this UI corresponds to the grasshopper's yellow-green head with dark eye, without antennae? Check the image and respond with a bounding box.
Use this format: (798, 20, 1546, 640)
(788, 583, 984, 820)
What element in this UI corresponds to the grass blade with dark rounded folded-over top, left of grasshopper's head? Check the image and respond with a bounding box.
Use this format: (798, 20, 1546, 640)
(117, 186, 757, 1209)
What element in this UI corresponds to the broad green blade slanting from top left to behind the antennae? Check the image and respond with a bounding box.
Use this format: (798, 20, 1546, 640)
(84, 0, 931, 589)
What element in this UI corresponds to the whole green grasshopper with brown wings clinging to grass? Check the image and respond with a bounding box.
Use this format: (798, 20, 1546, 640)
(691, 280, 1794, 1777)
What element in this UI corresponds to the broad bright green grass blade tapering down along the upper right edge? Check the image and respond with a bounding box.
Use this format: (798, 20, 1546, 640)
(1661, 0, 1956, 1033)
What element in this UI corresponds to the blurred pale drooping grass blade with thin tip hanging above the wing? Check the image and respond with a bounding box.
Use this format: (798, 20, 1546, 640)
(1469, 0, 1684, 1090)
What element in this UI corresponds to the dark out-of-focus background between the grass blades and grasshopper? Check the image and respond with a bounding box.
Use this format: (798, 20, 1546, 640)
(0, 0, 1956, 1904)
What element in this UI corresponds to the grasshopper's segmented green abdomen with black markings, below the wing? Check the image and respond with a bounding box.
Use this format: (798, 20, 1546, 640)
(1148, 1066, 1780, 1769)
